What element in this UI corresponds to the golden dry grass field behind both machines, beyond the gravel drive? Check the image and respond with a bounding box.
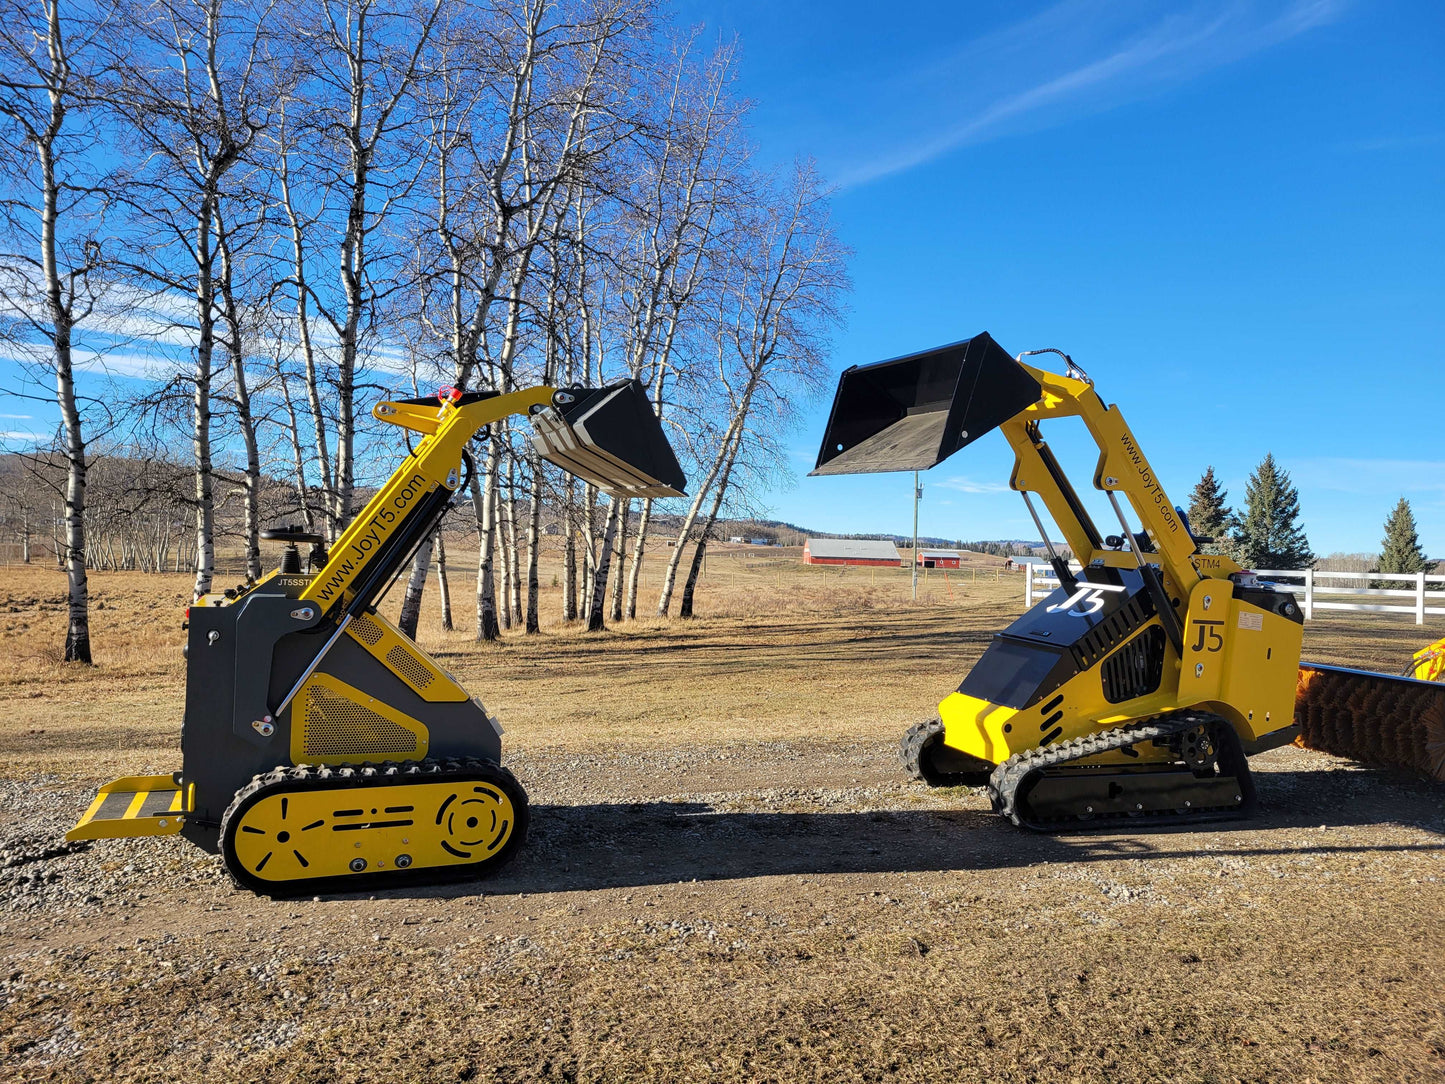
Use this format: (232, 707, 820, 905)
(0, 546, 1426, 779)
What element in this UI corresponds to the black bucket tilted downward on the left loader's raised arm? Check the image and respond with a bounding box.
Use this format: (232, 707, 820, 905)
(530, 380, 688, 497)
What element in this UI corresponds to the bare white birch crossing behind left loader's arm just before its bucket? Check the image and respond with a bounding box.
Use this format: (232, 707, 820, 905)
(410, 0, 652, 639)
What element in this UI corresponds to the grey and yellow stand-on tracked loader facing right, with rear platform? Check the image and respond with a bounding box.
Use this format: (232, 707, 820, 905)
(66, 380, 686, 895)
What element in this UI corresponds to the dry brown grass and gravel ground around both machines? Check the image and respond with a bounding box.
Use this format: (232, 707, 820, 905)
(0, 549, 1445, 1081)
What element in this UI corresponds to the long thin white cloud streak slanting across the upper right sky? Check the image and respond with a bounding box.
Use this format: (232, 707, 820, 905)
(834, 0, 1348, 188)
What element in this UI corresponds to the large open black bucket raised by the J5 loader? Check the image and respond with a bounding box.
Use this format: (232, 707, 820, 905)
(812, 331, 1042, 474)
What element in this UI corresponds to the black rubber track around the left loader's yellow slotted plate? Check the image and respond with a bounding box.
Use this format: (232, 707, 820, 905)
(220, 757, 527, 896)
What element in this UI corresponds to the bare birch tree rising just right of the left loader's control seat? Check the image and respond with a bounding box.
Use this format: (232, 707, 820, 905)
(270, 0, 442, 538)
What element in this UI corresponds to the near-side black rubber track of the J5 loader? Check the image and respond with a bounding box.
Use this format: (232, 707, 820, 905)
(988, 711, 1254, 833)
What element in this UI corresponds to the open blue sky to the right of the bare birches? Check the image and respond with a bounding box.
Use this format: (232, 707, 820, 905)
(679, 0, 1445, 556)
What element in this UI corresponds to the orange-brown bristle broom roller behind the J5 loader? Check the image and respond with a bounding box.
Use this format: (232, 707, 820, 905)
(1295, 666, 1445, 782)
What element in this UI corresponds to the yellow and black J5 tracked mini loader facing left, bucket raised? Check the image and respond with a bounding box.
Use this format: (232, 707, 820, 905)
(812, 334, 1445, 831)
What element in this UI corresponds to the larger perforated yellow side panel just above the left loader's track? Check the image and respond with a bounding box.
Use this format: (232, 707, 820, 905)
(290, 674, 428, 765)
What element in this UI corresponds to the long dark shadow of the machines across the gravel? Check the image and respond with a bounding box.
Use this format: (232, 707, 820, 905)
(375, 770, 1445, 898)
